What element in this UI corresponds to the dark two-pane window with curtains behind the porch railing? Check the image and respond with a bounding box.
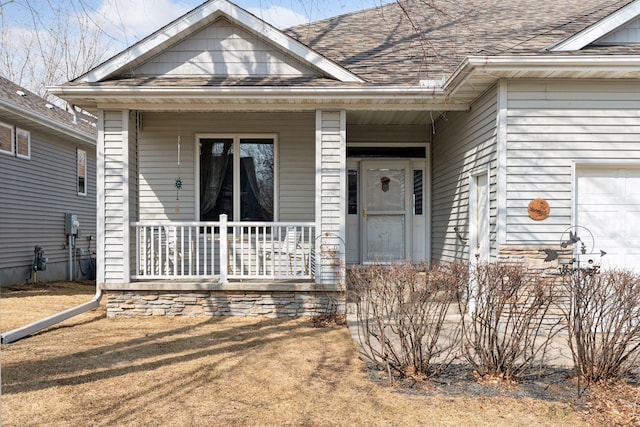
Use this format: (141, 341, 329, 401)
(200, 137, 275, 221)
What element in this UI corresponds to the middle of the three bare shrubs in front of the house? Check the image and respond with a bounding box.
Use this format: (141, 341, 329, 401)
(459, 263, 561, 380)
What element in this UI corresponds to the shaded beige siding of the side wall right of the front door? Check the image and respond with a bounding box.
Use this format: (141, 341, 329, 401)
(431, 88, 497, 261)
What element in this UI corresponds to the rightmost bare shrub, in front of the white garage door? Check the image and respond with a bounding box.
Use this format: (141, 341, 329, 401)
(563, 269, 640, 383)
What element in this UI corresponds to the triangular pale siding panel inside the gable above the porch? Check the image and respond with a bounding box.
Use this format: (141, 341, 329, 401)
(131, 18, 319, 78)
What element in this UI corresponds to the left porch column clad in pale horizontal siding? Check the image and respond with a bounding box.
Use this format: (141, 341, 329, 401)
(96, 110, 131, 285)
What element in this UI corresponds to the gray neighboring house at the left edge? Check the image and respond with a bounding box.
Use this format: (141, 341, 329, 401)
(0, 77, 96, 286)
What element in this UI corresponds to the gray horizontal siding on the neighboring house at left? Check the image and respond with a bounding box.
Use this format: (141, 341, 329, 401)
(0, 122, 96, 285)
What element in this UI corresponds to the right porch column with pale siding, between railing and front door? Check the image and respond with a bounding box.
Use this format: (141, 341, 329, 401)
(315, 110, 347, 285)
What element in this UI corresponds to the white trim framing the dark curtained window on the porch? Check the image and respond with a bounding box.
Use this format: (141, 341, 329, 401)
(193, 133, 280, 222)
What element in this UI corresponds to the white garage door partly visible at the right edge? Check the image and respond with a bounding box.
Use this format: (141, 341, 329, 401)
(577, 168, 640, 271)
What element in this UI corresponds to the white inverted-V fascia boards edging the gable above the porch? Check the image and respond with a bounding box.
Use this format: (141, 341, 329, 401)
(74, 0, 364, 83)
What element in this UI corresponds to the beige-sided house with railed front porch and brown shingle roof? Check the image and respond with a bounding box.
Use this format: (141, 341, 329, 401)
(51, 0, 640, 316)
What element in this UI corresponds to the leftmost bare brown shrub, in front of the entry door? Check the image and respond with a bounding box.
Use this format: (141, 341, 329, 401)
(349, 263, 466, 378)
